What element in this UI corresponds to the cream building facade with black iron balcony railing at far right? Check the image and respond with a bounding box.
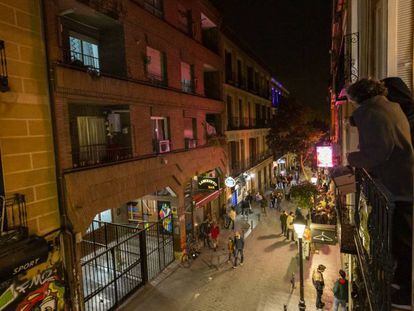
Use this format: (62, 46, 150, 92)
(331, 0, 414, 310)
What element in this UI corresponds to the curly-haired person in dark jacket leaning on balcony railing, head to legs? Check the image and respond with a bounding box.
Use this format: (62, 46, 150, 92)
(347, 79, 414, 310)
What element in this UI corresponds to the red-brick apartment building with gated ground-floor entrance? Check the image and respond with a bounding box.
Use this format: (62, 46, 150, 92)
(40, 0, 226, 310)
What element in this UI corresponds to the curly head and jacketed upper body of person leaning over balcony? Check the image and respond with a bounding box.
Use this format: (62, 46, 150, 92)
(347, 79, 414, 199)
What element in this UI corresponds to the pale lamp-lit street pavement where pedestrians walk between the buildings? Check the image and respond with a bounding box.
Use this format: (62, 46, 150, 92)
(120, 202, 340, 311)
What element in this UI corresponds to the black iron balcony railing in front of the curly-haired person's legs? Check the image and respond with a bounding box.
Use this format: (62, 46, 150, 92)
(354, 169, 412, 311)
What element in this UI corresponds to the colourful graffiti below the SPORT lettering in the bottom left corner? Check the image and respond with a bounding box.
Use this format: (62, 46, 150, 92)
(0, 250, 65, 311)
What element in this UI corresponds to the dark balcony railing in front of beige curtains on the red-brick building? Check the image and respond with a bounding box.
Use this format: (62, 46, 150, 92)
(72, 144, 132, 168)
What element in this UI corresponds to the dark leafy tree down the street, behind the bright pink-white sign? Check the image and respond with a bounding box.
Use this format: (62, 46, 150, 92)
(267, 97, 327, 178)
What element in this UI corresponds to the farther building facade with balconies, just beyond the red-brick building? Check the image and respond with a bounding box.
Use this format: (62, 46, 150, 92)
(223, 28, 288, 205)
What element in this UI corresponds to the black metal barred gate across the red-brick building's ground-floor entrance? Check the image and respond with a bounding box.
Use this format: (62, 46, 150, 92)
(81, 216, 174, 311)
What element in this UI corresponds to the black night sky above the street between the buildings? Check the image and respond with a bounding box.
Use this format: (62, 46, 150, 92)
(211, 0, 332, 118)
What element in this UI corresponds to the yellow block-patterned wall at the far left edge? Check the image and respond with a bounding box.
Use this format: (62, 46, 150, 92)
(0, 0, 59, 234)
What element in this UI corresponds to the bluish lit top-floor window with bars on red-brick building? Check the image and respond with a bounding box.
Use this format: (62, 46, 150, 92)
(69, 31, 99, 71)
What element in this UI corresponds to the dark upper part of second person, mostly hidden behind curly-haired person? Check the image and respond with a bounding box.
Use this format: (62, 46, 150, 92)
(382, 77, 414, 140)
